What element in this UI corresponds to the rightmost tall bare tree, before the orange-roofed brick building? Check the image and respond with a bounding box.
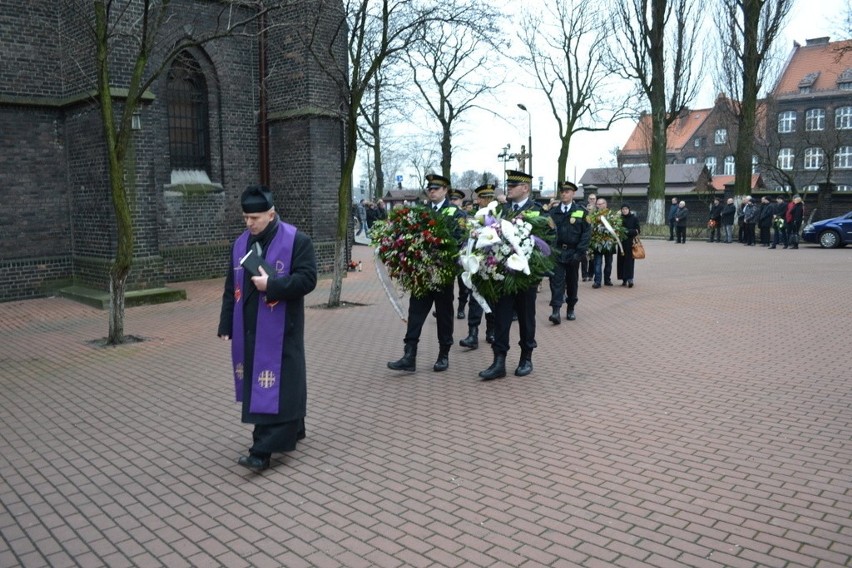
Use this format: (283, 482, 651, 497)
(715, 0, 793, 196)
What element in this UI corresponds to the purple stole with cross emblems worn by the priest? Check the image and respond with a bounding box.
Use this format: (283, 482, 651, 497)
(231, 221, 296, 414)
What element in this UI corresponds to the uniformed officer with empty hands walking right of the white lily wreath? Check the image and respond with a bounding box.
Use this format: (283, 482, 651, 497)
(547, 181, 592, 325)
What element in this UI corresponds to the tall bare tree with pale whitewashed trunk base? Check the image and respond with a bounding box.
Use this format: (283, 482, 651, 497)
(609, 0, 701, 225)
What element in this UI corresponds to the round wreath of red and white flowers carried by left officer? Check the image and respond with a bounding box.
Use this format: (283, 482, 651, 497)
(370, 205, 460, 298)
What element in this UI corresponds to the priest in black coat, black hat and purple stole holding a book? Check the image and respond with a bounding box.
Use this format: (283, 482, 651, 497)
(218, 186, 317, 472)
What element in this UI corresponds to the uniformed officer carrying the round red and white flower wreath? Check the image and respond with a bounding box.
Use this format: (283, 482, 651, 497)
(388, 174, 465, 372)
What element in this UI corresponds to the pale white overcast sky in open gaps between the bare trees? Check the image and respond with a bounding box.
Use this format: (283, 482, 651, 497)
(355, 0, 849, 195)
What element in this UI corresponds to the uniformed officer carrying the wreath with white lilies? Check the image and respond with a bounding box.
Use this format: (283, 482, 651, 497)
(479, 170, 541, 381)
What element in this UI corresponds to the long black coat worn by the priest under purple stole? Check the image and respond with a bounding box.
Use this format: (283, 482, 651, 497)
(219, 221, 317, 424)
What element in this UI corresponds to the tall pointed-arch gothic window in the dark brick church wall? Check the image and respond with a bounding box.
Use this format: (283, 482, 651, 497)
(166, 51, 210, 171)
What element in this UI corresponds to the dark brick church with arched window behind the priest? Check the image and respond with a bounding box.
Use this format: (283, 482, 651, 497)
(0, 0, 346, 301)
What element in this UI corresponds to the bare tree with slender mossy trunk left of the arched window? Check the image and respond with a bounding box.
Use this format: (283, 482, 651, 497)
(67, 0, 277, 345)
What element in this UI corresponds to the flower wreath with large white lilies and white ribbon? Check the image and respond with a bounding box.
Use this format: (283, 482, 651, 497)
(459, 201, 554, 313)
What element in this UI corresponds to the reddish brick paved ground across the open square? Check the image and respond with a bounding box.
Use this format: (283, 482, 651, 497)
(0, 236, 852, 568)
